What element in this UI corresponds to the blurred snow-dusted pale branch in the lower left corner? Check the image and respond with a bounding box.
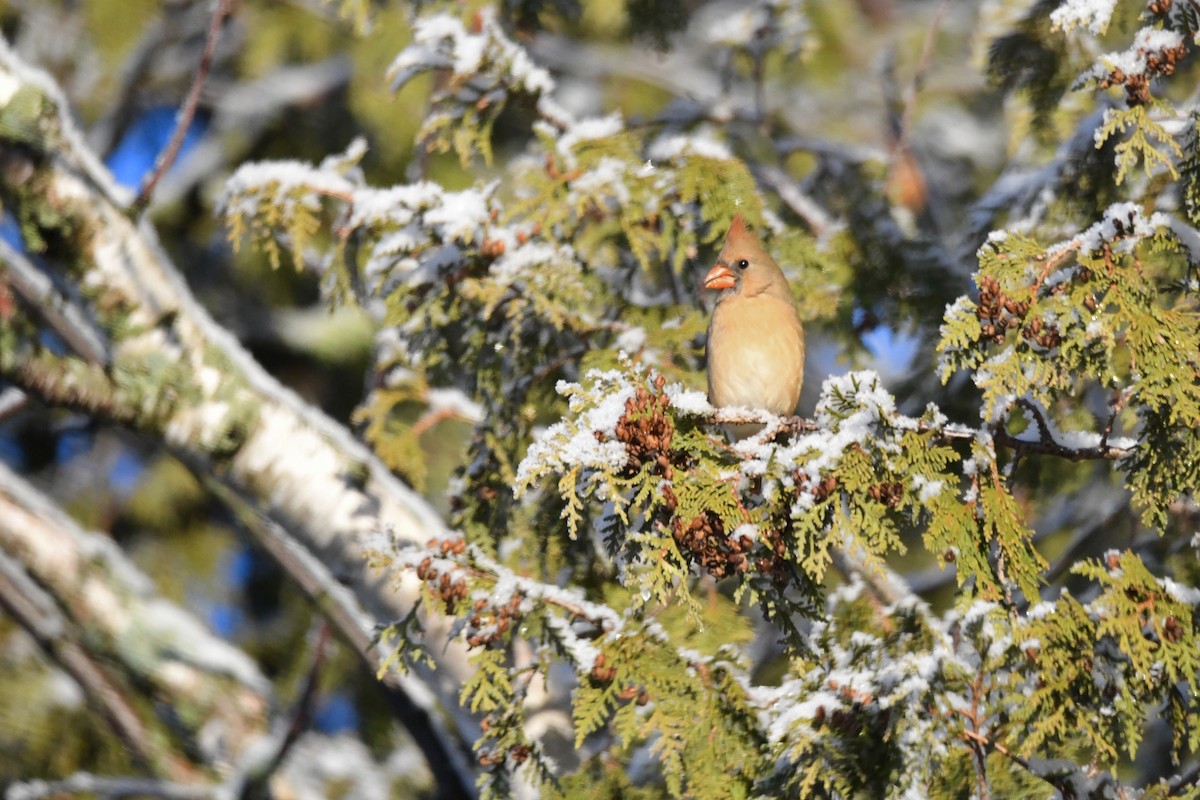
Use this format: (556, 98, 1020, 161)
(0, 464, 270, 780)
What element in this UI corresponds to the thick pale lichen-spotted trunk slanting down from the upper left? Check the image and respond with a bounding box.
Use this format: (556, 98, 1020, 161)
(0, 44, 474, 784)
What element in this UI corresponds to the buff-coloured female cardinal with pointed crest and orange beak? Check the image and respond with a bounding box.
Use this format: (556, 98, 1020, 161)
(704, 213, 804, 424)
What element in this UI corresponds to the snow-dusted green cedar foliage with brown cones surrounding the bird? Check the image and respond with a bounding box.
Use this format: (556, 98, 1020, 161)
(224, 2, 1200, 798)
